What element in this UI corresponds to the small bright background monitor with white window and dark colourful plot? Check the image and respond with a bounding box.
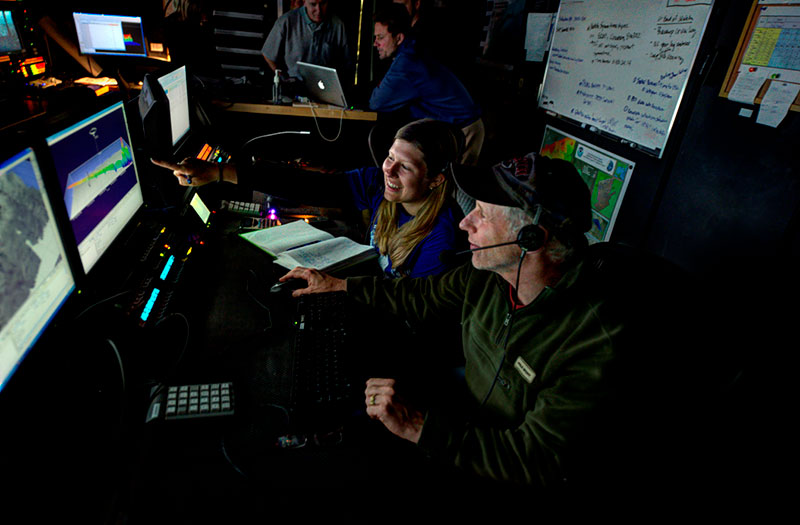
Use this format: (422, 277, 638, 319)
(72, 13, 147, 57)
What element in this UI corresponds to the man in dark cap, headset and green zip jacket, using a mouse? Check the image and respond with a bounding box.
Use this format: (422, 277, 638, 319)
(288, 153, 636, 487)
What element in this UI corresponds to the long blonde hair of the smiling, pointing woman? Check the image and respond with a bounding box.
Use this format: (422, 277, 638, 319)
(375, 119, 463, 270)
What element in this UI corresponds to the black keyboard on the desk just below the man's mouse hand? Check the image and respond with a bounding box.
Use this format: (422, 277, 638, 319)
(291, 292, 353, 410)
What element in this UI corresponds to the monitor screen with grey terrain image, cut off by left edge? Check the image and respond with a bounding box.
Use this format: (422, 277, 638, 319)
(0, 149, 75, 390)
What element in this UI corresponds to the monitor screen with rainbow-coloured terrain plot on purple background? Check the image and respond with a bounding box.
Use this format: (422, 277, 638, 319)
(46, 102, 144, 274)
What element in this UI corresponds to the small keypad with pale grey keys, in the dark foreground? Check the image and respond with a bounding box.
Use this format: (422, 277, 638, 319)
(147, 382, 234, 422)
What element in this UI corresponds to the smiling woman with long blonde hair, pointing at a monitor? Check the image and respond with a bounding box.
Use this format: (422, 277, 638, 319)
(153, 119, 467, 277)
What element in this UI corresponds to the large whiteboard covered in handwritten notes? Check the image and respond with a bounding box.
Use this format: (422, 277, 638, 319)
(539, 0, 713, 158)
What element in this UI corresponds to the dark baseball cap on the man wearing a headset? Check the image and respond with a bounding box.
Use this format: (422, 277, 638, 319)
(453, 153, 592, 233)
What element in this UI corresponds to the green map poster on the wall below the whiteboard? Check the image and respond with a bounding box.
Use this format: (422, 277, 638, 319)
(540, 126, 635, 243)
